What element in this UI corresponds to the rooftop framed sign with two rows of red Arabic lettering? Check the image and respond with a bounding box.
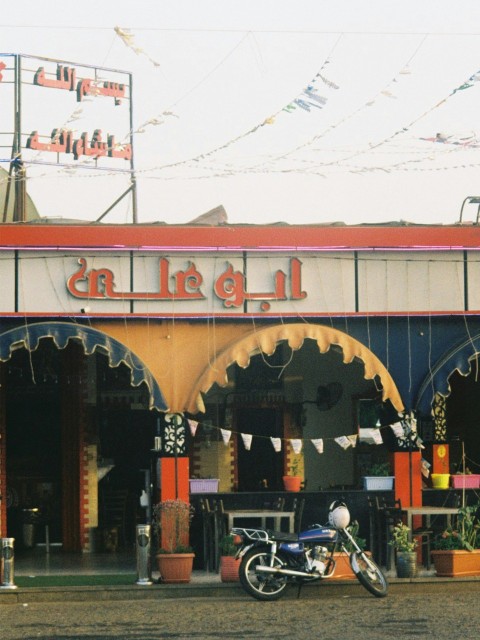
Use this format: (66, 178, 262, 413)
(0, 54, 133, 172)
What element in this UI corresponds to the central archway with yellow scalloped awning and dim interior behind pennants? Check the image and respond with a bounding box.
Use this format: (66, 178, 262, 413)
(192, 324, 403, 491)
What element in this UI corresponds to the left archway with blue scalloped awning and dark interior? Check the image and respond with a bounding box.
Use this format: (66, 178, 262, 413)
(0, 322, 166, 550)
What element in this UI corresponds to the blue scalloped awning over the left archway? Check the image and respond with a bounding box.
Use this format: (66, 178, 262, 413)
(0, 322, 167, 411)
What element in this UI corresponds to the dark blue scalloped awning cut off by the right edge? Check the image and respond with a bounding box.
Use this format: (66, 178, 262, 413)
(415, 334, 480, 415)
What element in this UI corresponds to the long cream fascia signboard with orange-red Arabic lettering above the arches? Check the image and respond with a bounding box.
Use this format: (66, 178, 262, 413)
(0, 249, 474, 317)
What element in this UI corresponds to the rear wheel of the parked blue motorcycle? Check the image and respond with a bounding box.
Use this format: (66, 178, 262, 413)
(239, 547, 287, 600)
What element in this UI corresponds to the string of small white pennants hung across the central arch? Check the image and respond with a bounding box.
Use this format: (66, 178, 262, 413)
(188, 416, 425, 454)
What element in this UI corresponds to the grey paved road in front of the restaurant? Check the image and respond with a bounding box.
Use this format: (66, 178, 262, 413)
(0, 583, 480, 640)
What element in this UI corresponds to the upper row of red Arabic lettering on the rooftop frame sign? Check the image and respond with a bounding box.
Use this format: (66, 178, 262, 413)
(33, 64, 125, 106)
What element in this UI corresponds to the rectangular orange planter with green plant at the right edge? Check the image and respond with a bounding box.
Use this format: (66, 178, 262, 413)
(432, 503, 480, 578)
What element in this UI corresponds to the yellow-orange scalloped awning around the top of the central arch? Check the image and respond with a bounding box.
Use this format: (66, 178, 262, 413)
(188, 323, 404, 413)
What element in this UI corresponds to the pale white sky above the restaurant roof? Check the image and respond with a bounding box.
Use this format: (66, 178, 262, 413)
(0, 0, 480, 224)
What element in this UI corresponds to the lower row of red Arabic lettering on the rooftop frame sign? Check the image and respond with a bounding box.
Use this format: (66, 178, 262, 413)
(26, 129, 132, 160)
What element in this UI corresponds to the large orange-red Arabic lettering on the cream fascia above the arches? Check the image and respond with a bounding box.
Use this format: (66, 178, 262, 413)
(67, 258, 307, 311)
